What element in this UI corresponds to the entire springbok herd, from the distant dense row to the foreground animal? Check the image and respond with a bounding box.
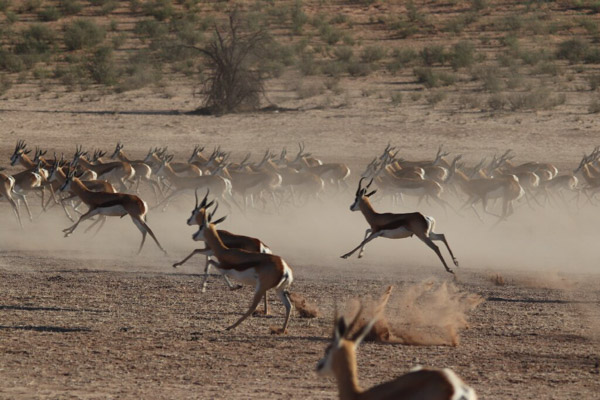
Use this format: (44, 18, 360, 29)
(0, 141, 600, 400)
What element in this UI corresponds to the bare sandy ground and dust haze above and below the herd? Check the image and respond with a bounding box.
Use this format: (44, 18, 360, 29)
(0, 80, 600, 399)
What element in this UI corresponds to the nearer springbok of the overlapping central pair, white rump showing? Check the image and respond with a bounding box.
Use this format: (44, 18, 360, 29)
(193, 208, 294, 333)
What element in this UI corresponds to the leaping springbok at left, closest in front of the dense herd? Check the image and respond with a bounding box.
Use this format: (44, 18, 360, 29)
(60, 169, 167, 255)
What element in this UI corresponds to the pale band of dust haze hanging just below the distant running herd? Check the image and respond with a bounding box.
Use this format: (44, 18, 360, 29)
(0, 175, 600, 278)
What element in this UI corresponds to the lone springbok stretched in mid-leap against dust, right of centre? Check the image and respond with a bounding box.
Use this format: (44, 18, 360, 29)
(342, 178, 458, 273)
